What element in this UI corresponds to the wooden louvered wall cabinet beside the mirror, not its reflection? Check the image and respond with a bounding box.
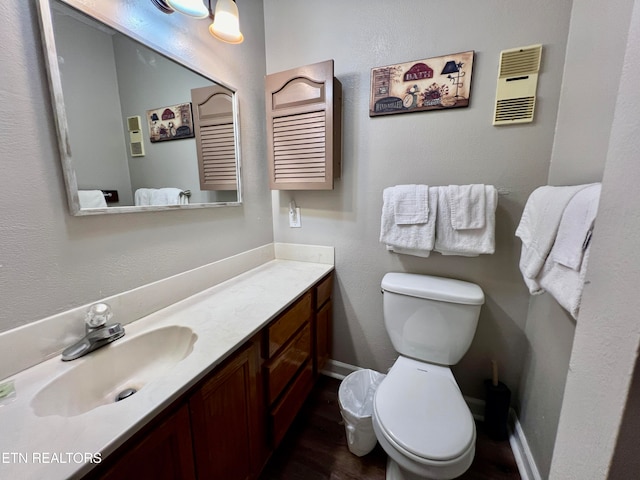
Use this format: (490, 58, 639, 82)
(265, 60, 342, 190)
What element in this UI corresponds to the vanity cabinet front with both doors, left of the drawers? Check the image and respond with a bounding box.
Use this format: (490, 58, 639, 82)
(85, 337, 268, 480)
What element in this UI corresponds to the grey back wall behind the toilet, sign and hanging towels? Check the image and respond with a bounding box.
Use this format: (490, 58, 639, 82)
(265, 0, 571, 399)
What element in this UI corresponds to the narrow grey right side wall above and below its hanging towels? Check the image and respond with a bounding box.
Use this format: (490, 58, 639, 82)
(519, 0, 633, 478)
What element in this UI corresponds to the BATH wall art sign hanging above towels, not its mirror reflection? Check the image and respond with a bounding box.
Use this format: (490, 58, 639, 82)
(369, 50, 474, 117)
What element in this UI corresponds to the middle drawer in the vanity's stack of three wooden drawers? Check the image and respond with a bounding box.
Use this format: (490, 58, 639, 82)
(265, 323, 311, 405)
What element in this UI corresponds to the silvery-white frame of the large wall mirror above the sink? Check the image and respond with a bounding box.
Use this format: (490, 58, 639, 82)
(38, 0, 242, 216)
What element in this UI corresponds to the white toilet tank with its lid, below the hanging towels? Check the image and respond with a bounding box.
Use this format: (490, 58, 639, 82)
(382, 273, 484, 365)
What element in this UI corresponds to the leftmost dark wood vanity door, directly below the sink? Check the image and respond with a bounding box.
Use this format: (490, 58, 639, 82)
(99, 405, 196, 480)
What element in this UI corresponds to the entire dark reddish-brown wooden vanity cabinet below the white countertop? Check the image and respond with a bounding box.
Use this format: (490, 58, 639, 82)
(85, 273, 333, 480)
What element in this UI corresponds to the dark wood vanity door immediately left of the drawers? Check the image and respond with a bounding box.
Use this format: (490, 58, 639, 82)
(189, 344, 264, 480)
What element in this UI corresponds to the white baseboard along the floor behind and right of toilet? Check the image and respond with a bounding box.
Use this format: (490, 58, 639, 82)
(320, 359, 542, 480)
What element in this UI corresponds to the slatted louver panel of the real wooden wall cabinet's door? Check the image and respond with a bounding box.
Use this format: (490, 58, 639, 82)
(273, 110, 326, 182)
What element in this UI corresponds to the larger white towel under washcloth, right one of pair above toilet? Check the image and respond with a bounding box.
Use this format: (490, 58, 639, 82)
(432, 185, 498, 257)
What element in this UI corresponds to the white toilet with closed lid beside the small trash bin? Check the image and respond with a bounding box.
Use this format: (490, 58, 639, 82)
(372, 273, 484, 480)
